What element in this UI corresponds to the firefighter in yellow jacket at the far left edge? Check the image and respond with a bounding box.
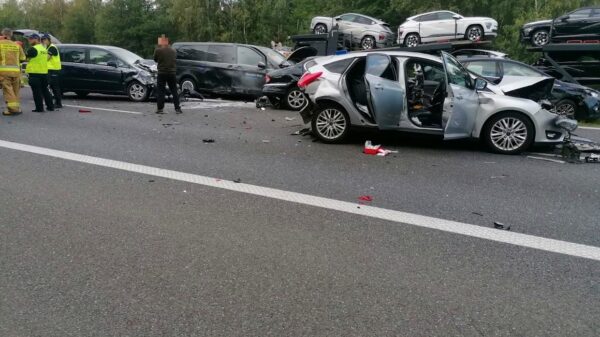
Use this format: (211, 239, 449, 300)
(0, 28, 25, 116)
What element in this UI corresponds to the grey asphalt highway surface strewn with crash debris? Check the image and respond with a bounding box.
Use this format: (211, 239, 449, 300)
(0, 89, 600, 337)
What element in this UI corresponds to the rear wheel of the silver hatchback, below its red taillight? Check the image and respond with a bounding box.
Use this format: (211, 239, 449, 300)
(311, 104, 350, 143)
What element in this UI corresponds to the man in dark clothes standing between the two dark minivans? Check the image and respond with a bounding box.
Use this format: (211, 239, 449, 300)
(154, 35, 181, 114)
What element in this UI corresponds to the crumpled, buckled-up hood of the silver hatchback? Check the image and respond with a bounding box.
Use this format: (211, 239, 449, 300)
(497, 76, 554, 102)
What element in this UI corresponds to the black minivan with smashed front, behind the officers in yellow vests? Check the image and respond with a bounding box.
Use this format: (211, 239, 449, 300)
(58, 44, 156, 102)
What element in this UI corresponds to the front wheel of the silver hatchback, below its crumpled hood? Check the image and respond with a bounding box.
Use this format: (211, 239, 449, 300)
(481, 112, 535, 154)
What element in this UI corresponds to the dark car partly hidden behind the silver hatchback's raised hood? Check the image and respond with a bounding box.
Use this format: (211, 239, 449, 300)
(461, 57, 600, 120)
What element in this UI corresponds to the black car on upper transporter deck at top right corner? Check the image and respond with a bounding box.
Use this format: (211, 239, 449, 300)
(521, 7, 600, 47)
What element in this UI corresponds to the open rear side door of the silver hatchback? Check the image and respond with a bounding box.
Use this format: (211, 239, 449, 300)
(365, 54, 406, 130)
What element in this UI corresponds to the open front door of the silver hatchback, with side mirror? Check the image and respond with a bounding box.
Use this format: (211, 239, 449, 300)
(442, 52, 479, 139)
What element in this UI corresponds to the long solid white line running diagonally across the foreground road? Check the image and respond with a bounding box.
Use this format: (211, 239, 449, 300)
(0, 140, 600, 261)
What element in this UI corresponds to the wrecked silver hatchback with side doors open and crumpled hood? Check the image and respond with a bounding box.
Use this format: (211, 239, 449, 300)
(298, 52, 577, 154)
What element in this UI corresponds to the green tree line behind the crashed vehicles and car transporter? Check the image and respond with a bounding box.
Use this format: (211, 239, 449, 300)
(0, 0, 600, 61)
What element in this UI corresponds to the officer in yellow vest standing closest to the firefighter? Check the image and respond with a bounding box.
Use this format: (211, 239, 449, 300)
(25, 34, 54, 112)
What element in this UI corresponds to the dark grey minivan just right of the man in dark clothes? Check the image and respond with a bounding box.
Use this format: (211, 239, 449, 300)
(173, 42, 290, 99)
